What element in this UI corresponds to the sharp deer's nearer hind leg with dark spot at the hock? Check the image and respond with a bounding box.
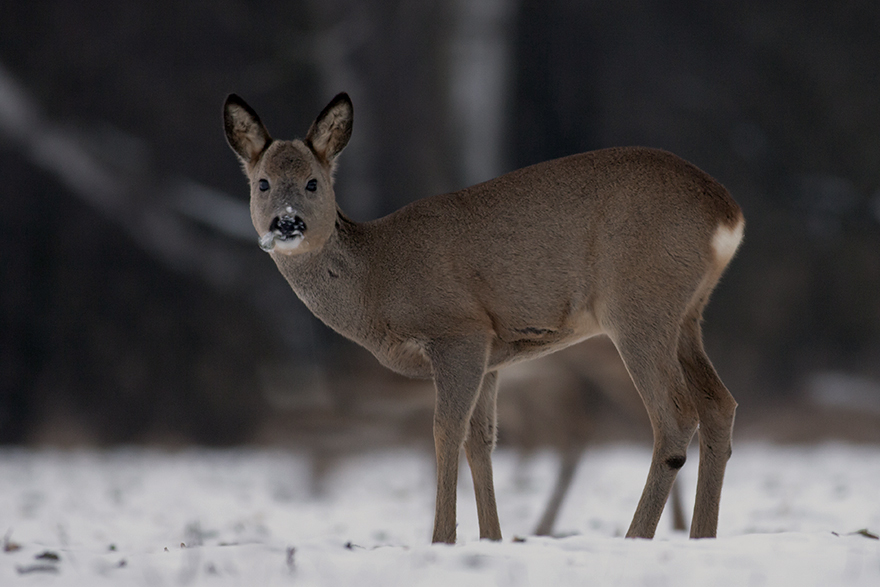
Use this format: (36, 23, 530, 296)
(615, 322, 697, 538)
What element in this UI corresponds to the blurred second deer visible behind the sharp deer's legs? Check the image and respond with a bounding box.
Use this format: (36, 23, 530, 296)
(498, 336, 686, 536)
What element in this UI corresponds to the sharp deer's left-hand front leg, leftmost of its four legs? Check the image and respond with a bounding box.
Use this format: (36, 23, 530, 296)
(429, 339, 492, 544)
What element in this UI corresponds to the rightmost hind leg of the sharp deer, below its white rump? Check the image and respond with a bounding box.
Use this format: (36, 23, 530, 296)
(678, 311, 736, 538)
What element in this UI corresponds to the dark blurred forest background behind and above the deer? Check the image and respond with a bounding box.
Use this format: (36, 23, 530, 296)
(0, 0, 880, 445)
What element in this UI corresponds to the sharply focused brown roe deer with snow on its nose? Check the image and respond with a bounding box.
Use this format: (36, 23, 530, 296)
(224, 94, 744, 543)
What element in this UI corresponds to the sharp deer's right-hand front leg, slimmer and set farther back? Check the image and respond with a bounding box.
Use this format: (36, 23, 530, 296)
(464, 371, 501, 540)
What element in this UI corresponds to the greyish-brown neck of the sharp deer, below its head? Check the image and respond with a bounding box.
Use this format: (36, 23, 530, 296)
(272, 210, 370, 344)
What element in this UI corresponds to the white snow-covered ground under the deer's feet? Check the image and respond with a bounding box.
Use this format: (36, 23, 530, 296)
(0, 443, 880, 587)
